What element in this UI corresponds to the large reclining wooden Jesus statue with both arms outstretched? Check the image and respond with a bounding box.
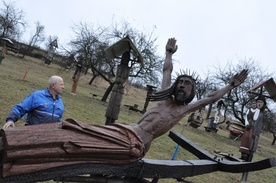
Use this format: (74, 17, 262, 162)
(1, 38, 248, 176)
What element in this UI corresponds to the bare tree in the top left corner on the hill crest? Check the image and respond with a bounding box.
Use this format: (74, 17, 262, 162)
(0, 1, 27, 38)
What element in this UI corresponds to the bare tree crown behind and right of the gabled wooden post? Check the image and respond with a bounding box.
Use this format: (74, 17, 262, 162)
(108, 21, 163, 85)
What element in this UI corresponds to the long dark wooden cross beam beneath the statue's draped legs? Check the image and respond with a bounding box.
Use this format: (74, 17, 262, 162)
(0, 159, 218, 183)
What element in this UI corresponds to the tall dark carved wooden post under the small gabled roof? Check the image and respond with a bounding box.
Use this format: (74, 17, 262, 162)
(105, 51, 130, 125)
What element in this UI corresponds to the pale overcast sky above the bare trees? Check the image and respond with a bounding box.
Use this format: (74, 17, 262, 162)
(6, 0, 276, 76)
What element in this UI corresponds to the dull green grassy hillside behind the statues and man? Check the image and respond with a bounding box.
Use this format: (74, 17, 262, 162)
(0, 51, 276, 183)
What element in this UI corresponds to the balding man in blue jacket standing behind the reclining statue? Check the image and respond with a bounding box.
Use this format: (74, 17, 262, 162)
(3, 76, 64, 128)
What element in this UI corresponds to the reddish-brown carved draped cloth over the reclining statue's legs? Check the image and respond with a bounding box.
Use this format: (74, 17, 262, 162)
(1, 119, 145, 176)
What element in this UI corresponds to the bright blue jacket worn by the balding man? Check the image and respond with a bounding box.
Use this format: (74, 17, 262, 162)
(6, 88, 64, 125)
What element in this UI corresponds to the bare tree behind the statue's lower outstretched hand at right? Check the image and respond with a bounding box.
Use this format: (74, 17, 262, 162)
(212, 58, 276, 144)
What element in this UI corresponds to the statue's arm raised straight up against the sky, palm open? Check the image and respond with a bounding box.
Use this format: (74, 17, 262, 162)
(161, 38, 178, 90)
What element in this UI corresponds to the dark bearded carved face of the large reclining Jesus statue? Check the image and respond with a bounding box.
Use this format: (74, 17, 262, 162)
(174, 77, 193, 104)
